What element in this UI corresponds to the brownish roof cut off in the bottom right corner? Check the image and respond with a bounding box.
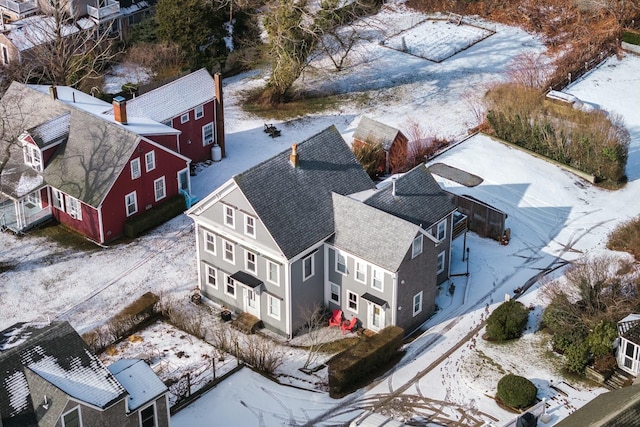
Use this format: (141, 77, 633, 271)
(556, 385, 640, 427)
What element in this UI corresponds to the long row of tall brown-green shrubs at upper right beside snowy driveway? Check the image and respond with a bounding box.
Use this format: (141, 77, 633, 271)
(486, 83, 630, 183)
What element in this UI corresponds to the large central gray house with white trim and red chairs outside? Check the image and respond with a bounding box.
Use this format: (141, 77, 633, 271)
(187, 126, 455, 336)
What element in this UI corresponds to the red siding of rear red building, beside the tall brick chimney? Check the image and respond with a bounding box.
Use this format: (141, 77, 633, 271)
(171, 101, 215, 162)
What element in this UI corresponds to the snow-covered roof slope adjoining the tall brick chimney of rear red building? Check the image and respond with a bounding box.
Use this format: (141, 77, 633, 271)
(127, 68, 215, 122)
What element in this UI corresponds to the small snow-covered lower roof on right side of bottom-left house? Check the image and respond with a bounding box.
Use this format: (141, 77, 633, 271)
(109, 359, 167, 411)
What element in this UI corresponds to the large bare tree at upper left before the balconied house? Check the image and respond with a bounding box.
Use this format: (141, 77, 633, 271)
(21, 0, 116, 86)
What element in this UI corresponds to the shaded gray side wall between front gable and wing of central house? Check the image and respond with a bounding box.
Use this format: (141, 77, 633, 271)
(290, 249, 325, 335)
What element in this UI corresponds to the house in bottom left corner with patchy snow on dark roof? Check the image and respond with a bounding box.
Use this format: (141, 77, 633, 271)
(0, 322, 170, 427)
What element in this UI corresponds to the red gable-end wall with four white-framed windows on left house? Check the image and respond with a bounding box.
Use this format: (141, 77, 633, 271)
(101, 141, 188, 242)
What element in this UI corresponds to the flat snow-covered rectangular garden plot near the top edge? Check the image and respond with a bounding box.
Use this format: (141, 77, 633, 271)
(384, 18, 494, 62)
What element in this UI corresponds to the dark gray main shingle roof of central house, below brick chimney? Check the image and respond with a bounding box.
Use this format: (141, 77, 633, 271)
(234, 126, 374, 259)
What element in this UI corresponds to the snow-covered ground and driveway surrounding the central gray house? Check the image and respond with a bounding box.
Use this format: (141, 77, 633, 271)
(0, 0, 640, 427)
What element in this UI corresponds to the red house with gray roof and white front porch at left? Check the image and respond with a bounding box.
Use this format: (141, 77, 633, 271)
(0, 82, 191, 243)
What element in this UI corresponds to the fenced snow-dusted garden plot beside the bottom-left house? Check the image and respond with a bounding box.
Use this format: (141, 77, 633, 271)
(98, 321, 238, 406)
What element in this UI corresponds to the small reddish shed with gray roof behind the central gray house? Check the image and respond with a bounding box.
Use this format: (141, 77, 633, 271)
(353, 116, 408, 175)
